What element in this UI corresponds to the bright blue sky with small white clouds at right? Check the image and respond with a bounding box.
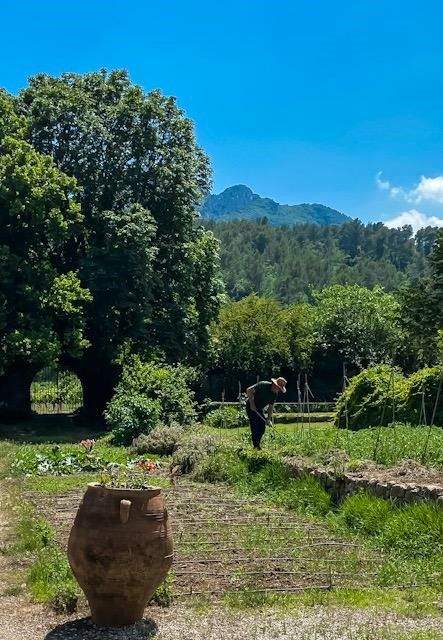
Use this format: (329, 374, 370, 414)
(0, 0, 443, 226)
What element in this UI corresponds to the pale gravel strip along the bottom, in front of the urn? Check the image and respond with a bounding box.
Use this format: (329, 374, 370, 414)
(0, 602, 443, 640)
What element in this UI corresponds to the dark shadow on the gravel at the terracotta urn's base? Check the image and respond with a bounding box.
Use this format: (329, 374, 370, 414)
(44, 618, 158, 640)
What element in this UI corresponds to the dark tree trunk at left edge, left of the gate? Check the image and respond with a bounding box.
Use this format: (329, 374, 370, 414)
(0, 364, 37, 419)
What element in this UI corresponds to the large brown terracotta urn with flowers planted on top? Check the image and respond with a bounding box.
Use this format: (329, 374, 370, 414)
(68, 484, 172, 627)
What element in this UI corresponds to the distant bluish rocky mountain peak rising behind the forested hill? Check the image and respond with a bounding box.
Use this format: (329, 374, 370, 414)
(200, 184, 350, 225)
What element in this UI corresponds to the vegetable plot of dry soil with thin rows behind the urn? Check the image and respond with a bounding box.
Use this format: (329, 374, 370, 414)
(30, 482, 386, 599)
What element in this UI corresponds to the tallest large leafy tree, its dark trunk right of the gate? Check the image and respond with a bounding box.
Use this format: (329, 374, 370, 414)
(20, 71, 219, 412)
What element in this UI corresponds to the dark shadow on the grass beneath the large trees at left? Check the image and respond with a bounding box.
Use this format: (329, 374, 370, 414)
(0, 413, 105, 444)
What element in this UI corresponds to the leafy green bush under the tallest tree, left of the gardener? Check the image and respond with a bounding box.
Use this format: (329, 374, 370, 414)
(105, 356, 195, 444)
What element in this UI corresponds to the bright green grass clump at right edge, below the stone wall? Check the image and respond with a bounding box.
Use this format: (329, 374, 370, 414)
(381, 502, 443, 557)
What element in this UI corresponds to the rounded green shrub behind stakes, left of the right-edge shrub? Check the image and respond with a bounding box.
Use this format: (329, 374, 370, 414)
(335, 365, 406, 431)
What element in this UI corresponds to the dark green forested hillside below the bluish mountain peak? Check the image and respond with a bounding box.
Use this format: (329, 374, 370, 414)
(205, 219, 438, 303)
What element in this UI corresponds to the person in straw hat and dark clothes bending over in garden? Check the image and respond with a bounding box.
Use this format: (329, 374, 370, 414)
(246, 378, 287, 449)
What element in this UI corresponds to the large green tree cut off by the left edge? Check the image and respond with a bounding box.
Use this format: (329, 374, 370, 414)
(0, 92, 89, 414)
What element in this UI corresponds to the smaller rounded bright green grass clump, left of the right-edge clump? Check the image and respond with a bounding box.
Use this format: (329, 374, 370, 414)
(339, 492, 392, 536)
